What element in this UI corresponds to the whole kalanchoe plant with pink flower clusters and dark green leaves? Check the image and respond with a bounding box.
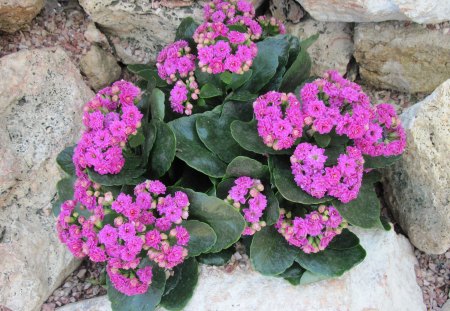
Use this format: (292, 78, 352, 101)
(54, 0, 406, 310)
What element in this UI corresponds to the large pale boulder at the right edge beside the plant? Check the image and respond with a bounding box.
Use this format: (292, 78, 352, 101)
(384, 79, 450, 254)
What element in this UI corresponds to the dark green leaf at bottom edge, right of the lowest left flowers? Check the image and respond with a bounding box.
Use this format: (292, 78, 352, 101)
(161, 258, 198, 311)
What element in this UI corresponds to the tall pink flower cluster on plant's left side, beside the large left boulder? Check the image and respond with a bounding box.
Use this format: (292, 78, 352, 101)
(73, 80, 142, 177)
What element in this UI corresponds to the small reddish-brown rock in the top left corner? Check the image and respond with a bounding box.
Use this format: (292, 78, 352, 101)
(0, 0, 45, 33)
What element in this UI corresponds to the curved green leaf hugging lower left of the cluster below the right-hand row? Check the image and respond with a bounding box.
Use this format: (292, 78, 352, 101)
(269, 157, 332, 205)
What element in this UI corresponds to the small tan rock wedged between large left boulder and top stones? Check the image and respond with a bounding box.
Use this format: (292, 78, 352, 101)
(80, 45, 122, 91)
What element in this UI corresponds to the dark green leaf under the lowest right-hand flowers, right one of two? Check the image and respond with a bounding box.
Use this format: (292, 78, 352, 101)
(295, 245, 366, 277)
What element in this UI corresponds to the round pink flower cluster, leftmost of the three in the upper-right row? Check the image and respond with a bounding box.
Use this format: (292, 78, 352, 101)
(253, 91, 303, 150)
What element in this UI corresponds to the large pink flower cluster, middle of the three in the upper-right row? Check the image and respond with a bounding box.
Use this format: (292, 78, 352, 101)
(300, 71, 373, 139)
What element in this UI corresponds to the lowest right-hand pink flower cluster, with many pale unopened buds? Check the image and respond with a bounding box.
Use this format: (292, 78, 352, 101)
(275, 205, 348, 254)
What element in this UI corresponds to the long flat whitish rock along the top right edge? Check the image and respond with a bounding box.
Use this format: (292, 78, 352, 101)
(296, 0, 450, 24)
